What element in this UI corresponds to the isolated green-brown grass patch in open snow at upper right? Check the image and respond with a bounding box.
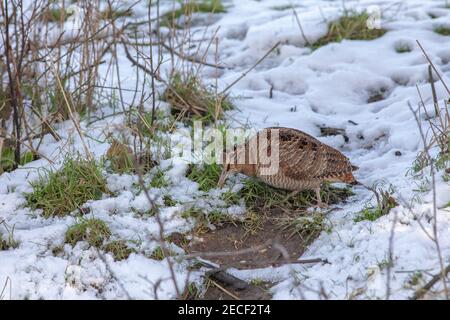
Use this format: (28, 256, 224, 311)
(312, 12, 386, 49)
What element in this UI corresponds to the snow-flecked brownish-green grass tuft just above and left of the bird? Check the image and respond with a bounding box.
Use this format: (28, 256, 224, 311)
(162, 72, 233, 123)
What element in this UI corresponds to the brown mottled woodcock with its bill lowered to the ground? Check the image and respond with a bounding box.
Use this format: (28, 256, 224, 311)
(218, 127, 358, 206)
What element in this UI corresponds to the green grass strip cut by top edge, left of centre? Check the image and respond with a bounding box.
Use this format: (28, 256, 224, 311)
(160, 0, 226, 28)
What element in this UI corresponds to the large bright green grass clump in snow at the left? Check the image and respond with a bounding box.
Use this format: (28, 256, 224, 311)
(25, 158, 108, 218)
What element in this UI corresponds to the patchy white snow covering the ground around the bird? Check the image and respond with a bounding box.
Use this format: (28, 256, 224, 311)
(0, 0, 450, 299)
